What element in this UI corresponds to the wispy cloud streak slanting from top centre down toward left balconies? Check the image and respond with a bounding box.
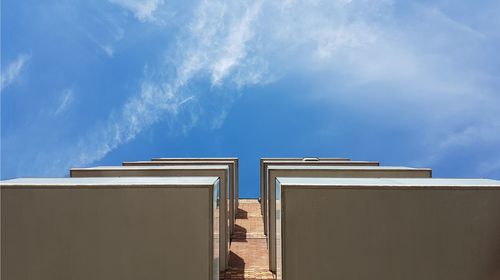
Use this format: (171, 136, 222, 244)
(65, 1, 265, 170)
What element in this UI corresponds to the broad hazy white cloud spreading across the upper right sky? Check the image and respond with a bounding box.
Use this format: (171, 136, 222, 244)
(250, 1, 500, 167)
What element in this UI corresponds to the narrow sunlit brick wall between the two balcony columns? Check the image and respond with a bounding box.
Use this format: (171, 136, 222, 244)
(220, 199, 276, 280)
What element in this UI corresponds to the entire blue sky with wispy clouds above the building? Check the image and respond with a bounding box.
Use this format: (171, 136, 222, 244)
(0, 0, 500, 197)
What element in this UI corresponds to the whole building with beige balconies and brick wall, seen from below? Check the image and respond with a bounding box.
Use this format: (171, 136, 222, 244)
(0, 157, 500, 280)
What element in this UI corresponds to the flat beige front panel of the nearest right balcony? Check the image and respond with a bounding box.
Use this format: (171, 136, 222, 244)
(281, 179, 500, 280)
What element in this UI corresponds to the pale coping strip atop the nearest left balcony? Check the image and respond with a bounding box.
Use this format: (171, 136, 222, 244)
(0, 177, 218, 188)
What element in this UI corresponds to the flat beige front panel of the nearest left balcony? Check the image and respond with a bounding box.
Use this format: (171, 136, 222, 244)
(1, 182, 214, 280)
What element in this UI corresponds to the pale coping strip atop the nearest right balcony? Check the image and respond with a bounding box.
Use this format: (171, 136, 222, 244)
(276, 177, 500, 189)
